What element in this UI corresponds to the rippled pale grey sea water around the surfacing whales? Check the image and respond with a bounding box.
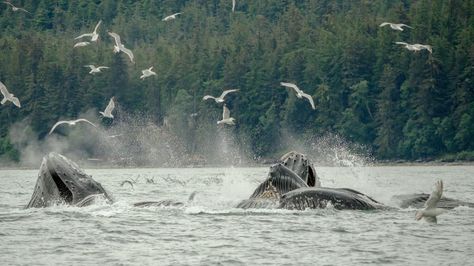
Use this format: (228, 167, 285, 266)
(0, 166, 474, 265)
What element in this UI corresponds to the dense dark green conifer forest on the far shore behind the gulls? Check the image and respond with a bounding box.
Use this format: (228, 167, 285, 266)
(0, 0, 474, 163)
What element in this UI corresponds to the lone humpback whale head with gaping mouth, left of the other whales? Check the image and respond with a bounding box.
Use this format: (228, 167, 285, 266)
(26, 153, 112, 208)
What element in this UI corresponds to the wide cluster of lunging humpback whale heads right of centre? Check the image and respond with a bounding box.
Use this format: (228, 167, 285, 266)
(237, 151, 384, 210)
